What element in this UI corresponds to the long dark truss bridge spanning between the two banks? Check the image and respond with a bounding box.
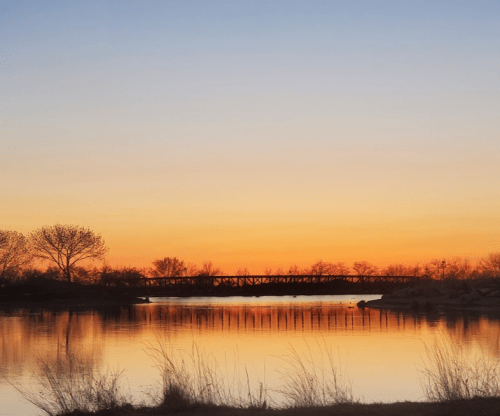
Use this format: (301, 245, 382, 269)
(104, 275, 420, 295)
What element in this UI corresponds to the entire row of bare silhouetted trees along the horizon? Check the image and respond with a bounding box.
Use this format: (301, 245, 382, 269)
(0, 224, 500, 284)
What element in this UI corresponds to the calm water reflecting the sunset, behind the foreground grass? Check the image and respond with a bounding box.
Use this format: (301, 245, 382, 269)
(0, 295, 500, 416)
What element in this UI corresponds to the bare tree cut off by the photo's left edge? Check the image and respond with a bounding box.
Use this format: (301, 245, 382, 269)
(0, 230, 33, 279)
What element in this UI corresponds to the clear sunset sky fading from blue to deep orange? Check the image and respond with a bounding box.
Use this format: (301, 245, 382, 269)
(0, 0, 500, 274)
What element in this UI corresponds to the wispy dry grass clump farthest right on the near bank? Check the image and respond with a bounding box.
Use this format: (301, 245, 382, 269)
(420, 336, 500, 402)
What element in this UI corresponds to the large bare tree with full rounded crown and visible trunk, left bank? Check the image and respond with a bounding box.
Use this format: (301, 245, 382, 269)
(29, 224, 108, 282)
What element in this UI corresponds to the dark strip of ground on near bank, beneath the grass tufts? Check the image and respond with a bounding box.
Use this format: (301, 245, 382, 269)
(66, 398, 500, 416)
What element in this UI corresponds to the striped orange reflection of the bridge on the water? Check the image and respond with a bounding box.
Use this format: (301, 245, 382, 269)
(128, 303, 425, 332)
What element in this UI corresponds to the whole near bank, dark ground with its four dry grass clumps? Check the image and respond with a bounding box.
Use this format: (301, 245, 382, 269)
(6, 338, 500, 416)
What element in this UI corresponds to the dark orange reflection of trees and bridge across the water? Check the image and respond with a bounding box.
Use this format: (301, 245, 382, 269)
(0, 303, 500, 372)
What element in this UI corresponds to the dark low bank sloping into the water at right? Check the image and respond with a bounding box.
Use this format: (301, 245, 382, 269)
(358, 279, 500, 313)
